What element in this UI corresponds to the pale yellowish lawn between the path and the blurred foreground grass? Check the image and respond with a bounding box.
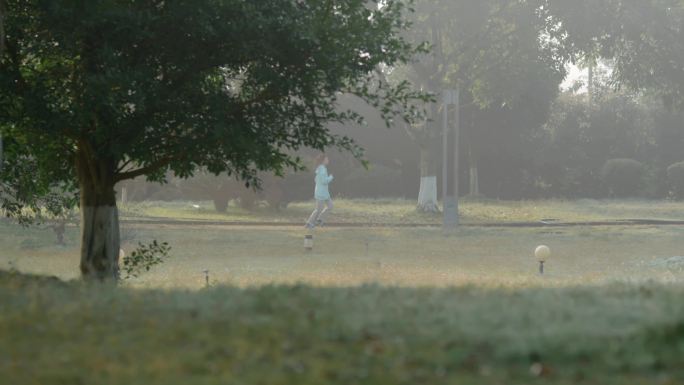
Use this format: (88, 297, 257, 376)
(0, 214, 684, 289)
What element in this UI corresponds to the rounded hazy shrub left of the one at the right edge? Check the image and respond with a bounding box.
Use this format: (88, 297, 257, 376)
(601, 159, 645, 198)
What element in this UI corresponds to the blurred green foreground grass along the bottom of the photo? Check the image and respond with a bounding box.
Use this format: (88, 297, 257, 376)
(0, 271, 684, 385)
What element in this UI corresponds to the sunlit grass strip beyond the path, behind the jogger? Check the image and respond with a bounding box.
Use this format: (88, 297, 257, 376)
(115, 199, 684, 224)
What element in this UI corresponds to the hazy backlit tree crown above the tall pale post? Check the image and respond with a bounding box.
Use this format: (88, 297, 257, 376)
(409, 0, 565, 106)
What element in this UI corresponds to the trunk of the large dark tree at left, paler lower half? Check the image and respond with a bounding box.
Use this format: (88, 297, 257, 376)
(76, 148, 119, 282)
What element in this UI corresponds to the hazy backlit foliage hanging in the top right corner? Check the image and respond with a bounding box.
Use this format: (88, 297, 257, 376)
(545, 0, 684, 108)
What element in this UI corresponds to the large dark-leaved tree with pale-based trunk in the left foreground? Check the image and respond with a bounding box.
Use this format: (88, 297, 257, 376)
(0, 0, 421, 280)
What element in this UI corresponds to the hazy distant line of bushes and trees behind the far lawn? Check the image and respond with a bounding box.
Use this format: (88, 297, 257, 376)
(129, 80, 684, 208)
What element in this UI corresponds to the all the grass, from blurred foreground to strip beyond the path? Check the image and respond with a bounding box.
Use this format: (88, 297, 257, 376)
(0, 201, 684, 385)
